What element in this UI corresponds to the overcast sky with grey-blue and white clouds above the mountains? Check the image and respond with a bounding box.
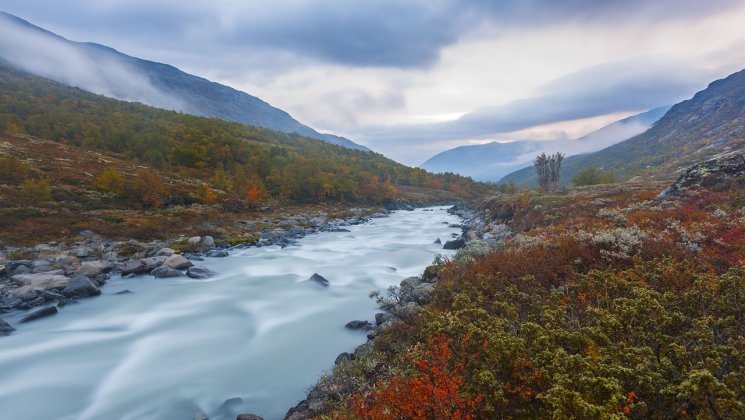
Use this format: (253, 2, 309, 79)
(0, 0, 745, 164)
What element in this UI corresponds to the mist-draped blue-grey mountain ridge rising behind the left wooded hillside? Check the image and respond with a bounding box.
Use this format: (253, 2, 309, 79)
(0, 12, 369, 151)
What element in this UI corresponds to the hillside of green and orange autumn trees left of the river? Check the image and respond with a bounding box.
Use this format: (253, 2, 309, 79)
(0, 65, 488, 243)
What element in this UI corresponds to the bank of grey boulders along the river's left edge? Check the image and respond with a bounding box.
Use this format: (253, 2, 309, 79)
(0, 207, 396, 335)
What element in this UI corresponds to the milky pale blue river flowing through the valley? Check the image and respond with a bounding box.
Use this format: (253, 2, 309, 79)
(0, 208, 459, 420)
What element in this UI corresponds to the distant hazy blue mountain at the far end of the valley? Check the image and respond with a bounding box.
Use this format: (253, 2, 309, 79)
(421, 107, 669, 181)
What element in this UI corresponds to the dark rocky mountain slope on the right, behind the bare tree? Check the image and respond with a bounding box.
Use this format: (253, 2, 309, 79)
(502, 70, 745, 184)
